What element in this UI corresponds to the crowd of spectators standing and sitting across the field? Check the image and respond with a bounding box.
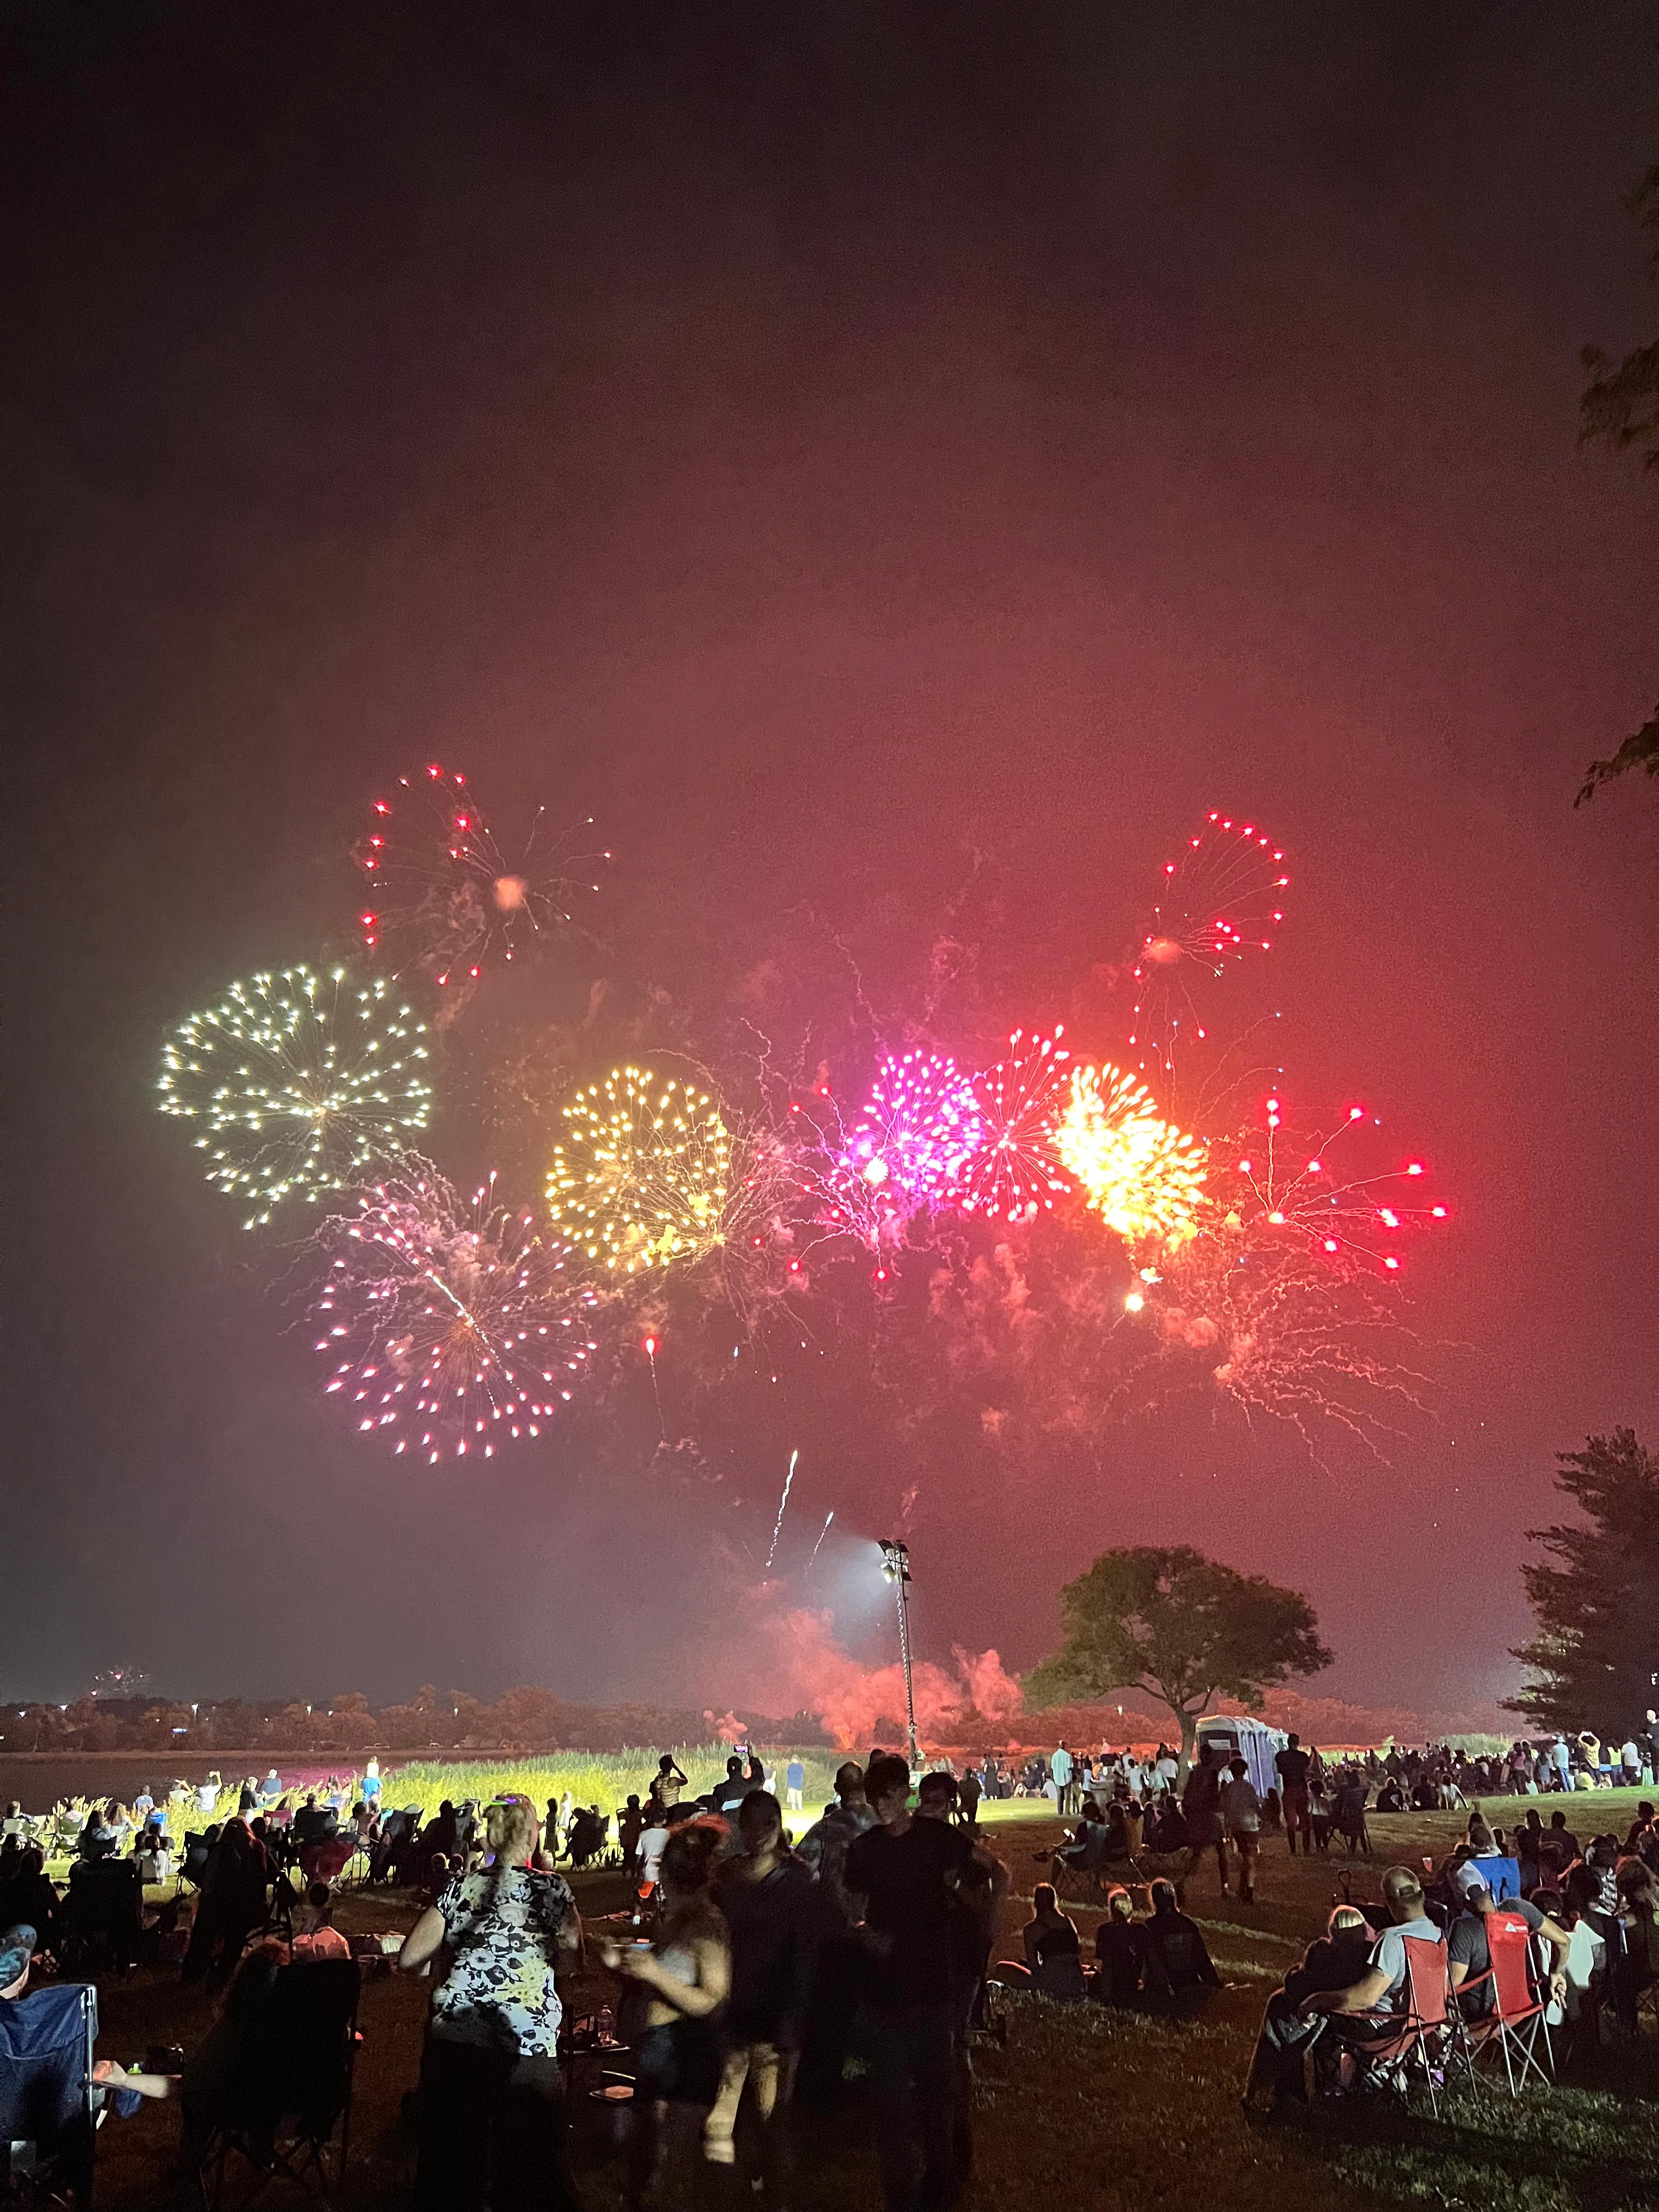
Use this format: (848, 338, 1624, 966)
(0, 1736, 1659, 2212)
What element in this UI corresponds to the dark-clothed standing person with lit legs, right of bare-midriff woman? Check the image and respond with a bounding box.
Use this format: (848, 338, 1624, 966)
(703, 1790, 819, 2205)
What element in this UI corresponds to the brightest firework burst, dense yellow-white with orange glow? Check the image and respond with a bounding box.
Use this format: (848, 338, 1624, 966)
(1053, 1066, 1207, 1243)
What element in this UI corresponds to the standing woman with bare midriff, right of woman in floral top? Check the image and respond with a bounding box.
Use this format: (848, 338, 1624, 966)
(600, 1818, 732, 2212)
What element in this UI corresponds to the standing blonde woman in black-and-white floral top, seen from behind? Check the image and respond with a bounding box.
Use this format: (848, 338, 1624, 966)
(398, 1796, 582, 2212)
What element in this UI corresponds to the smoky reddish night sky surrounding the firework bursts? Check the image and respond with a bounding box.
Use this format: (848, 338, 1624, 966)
(0, 0, 1659, 1710)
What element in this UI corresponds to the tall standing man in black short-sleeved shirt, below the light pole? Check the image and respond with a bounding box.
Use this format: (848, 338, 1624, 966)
(847, 1752, 973, 2212)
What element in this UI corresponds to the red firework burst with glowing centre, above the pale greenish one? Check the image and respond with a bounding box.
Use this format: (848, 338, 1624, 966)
(352, 761, 611, 984)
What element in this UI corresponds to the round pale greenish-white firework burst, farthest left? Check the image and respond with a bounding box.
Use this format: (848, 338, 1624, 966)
(157, 967, 431, 1228)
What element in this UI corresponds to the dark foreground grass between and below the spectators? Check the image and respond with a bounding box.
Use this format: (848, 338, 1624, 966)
(75, 1794, 1659, 2212)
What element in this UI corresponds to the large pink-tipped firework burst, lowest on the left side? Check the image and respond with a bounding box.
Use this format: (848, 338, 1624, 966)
(312, 1172, 595, 1464)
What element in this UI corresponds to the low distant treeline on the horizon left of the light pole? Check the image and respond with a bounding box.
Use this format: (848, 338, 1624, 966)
(0, 1683, 827, 1756)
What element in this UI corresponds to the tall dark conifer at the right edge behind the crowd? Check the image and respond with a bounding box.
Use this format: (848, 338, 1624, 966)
(1509, 1429, 1659, 1736)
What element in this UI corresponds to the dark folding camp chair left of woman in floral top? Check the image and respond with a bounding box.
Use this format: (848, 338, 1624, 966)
(199, 1957, 363, 2212)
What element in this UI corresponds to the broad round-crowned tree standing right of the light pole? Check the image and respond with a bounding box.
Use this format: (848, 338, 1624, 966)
(1024, 1544, 1331, 1770)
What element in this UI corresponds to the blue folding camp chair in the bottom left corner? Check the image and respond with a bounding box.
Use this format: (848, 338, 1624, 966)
(0, 1982, 97, 2205)
